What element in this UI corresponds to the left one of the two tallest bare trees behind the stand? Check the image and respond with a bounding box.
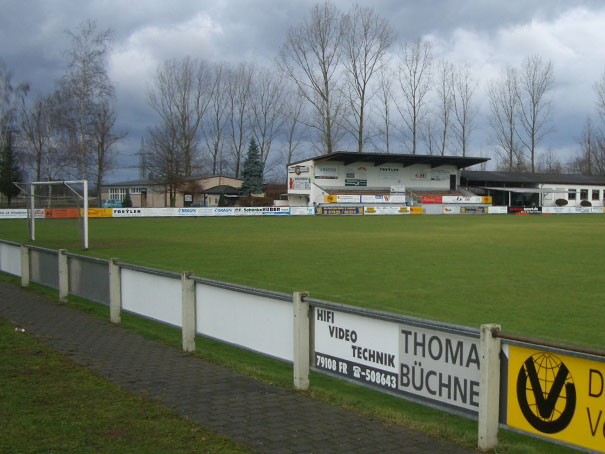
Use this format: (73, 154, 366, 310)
(278, 1, 342, 153)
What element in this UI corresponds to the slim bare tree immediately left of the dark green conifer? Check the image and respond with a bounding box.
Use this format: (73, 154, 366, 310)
(227, 63, 256, 178)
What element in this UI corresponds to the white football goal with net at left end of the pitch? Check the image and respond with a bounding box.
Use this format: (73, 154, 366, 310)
(19, 180, 88, 249)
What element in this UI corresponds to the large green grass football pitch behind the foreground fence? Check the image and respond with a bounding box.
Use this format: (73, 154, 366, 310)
(0, 215, 605, 348)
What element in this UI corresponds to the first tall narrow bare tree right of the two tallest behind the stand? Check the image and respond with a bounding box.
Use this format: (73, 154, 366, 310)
(397, 39, 432, 154)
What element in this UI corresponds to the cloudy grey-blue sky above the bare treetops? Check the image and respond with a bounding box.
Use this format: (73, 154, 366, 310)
(0, 0, 605, 181)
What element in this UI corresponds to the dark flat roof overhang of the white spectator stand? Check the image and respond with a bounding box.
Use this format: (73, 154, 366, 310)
(288, 151, 489, 169)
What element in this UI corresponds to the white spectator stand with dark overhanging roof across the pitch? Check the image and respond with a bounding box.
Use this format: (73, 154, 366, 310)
(288, 152, 488, 206)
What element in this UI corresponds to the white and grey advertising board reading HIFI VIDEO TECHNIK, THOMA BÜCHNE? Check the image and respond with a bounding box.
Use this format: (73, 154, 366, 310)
(314, 308, 480, 414)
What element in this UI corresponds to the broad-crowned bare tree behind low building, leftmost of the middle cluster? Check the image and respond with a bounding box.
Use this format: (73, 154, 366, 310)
(148, 57, 210, 176)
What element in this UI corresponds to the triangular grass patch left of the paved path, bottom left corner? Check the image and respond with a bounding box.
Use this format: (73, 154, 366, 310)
(0, 310, 251, 454)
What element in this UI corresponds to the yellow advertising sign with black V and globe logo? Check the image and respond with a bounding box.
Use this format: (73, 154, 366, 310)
(506, 345, 605, 452)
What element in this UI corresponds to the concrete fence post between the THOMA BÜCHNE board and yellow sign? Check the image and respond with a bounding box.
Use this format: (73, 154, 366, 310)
(478, 324, 500, 451)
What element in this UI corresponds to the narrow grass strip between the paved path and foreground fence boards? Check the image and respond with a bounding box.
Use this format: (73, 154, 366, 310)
(0, 276, 576, 454)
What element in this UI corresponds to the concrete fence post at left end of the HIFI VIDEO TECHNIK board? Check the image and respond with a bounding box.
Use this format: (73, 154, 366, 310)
(292, 292, 310, 391)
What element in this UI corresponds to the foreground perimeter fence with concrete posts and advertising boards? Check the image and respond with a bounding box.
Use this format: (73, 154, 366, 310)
(0, 240, 605, 452)
